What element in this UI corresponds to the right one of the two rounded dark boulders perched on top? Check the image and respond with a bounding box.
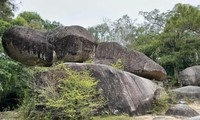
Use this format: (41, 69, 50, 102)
(46, 26, 96, 62)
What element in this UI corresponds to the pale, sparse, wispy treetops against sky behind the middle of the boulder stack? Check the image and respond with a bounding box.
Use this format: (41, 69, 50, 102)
(88, 15, 136, 46)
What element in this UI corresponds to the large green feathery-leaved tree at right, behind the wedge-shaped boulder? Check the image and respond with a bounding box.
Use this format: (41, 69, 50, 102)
(134, 4, 200, 85)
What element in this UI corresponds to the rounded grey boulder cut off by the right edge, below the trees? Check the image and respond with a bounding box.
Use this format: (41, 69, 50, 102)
(180, 66, 200, 86)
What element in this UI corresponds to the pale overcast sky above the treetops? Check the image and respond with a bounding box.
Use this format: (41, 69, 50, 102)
(16, 0, 200, 27)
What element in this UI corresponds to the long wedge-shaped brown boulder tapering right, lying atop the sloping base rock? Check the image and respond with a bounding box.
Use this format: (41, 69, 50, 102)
(94, 42, 166, 80)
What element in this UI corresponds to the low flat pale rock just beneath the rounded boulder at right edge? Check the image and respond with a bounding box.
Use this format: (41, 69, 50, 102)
(172, 86, 200, 100)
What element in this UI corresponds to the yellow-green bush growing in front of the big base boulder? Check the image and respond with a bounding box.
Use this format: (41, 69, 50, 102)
(36, 64, 104, 120)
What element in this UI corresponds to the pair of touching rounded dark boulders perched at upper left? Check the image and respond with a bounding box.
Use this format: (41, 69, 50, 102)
(2, 26, 96, 66)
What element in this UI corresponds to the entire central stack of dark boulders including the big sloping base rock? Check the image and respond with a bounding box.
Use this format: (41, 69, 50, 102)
(2, 26, 166, 115)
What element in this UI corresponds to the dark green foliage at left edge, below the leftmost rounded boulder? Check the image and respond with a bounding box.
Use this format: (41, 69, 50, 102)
(0, 56, 32, 109)
